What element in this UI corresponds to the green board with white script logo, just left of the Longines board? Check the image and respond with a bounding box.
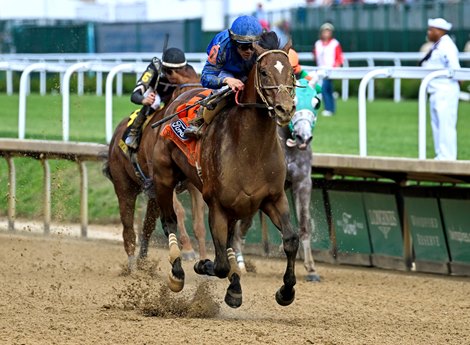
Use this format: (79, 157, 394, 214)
(328, 191, 371, 254)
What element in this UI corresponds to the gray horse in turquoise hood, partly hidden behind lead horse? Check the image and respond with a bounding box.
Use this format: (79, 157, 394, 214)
(234, 79, 321, 281)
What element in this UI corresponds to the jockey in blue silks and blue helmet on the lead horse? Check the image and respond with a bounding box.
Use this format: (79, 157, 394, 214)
(184, 16, 263, 138)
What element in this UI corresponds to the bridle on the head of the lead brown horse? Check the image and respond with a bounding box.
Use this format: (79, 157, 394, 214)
(235, 49, 295, 118)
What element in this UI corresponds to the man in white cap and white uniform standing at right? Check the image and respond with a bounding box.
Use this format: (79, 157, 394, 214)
(419, 18, 460, 160)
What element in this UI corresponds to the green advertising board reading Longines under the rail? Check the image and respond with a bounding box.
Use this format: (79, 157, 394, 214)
(363, 193, 403, 257)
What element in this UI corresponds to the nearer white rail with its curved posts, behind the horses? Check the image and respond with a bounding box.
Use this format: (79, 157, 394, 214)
(9, 61, 470, 159)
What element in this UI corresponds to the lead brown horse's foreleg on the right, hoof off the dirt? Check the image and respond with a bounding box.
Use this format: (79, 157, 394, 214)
(261, 193, 299, 306)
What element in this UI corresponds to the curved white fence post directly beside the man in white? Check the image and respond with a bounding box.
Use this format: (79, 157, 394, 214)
(418, 69, 453, 159)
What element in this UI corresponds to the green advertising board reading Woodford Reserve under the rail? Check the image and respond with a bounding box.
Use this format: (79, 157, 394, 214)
(405, 197, 449, 263)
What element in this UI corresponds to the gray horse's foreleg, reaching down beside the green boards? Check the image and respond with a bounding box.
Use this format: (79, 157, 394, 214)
(292, 175, 320, 282)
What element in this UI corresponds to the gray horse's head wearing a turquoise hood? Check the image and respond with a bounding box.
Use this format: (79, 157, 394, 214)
(286, 79, 320, 150)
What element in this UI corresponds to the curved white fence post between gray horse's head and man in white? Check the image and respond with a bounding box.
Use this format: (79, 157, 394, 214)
(358, 68, 390, 157)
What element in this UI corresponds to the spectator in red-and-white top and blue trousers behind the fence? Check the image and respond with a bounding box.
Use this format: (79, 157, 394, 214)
(313, 22, 344, 116)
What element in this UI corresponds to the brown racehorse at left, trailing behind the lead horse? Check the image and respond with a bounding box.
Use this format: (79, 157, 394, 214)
(103, 71, 207, 271)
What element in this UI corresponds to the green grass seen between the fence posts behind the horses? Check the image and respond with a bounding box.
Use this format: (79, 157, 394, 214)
(0, 94, 470, 223)
